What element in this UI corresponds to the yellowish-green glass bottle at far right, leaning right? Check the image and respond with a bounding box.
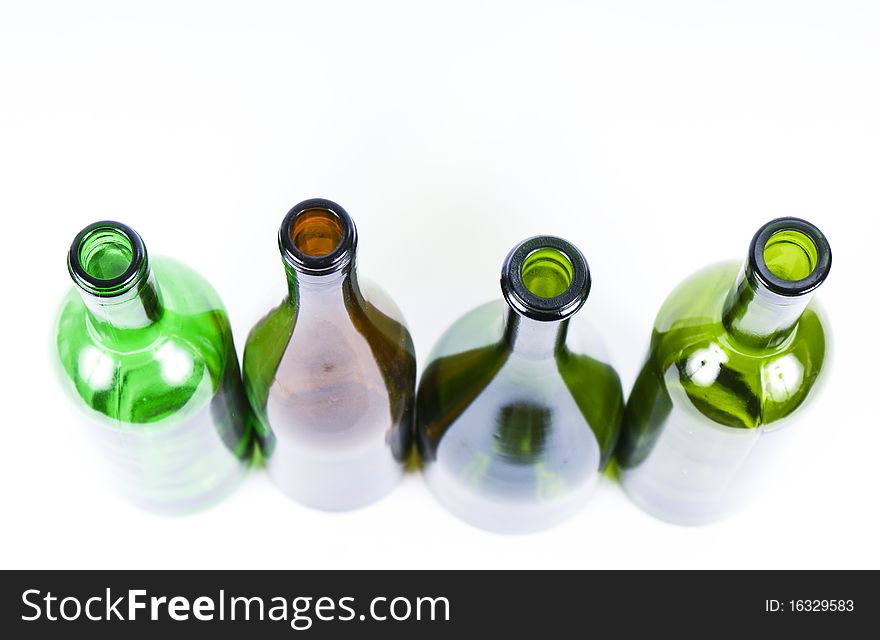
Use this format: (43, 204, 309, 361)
(616, 218, 831, 524)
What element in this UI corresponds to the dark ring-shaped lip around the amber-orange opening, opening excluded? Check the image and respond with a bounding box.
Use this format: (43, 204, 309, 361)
(278, 198, 357, 275)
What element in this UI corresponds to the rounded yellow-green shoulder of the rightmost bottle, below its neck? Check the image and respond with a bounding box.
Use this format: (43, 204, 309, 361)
(649, 262, 828, 428)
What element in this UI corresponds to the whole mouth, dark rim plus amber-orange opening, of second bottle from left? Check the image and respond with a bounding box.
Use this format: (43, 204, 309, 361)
(278, 198, 357, 275)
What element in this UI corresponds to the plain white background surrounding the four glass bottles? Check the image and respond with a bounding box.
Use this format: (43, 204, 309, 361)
(0, 0, 880, 568)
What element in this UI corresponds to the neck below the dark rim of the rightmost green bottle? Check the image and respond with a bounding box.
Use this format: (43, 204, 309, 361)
(722, 263, 813, 348)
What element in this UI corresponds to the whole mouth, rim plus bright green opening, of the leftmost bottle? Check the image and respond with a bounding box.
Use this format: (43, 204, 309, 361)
(67, 220, 147, 296)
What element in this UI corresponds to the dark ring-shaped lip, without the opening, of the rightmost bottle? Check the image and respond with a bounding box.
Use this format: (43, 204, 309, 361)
(749, 216, 831, 296)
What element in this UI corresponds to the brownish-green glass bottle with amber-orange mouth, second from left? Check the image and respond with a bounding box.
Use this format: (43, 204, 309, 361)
(244, 199, 416, 511)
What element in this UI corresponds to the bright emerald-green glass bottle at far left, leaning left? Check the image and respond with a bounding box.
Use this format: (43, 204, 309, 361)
(56, 221, 254, 512)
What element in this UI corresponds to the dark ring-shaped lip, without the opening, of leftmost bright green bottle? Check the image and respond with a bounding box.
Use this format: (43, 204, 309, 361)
(67, 220, 148, 298)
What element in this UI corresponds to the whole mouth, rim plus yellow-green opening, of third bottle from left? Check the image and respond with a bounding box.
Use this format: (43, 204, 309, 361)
(501, 236, 591, 321)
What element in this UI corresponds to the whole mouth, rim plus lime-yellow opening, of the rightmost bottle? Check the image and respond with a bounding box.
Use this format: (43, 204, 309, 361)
(749, 217, 831, 296)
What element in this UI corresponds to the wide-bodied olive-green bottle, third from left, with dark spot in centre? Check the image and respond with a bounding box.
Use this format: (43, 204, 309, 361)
(416, 236, 623, 533)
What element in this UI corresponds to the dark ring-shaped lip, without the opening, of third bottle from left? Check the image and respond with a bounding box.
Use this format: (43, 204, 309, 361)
(501, 236, 592, 322)
